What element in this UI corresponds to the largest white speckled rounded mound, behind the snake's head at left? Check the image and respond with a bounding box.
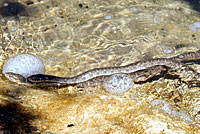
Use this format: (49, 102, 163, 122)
(2, 54, 45, 78)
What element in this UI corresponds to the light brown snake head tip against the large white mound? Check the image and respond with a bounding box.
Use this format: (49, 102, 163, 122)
(4, 72, 26, 84)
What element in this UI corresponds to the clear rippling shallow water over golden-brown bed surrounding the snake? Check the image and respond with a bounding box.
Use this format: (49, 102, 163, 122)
(0, 0, 200, 133)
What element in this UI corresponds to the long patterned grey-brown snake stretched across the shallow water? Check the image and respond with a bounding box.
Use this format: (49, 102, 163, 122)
(5, 51, 200, 86)
